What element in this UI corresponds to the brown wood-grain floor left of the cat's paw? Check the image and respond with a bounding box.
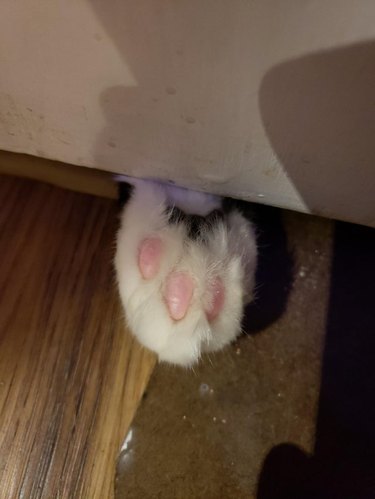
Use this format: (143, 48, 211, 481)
(0, 176, 155, 499)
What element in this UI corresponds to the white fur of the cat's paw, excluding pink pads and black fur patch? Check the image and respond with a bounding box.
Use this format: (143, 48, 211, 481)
(115, 178, 256, 365)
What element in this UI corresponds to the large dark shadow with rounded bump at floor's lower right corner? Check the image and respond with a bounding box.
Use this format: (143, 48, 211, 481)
(257, 223, 375, 499)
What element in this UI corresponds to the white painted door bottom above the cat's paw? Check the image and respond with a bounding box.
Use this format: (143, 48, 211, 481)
(0, 0, 375, 225)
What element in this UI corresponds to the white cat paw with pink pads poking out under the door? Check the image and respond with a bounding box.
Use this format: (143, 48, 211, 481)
(116, 180, 256, 365)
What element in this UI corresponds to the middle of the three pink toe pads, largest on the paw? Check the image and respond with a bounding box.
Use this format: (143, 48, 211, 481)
(164, 272, 194, 321)
